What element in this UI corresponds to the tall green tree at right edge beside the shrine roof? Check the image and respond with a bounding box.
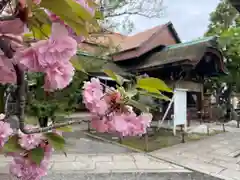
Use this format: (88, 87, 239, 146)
(206, 0, 240, 118)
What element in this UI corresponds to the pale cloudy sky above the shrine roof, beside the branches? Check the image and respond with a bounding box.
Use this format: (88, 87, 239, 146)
(131, 0, 220, 41)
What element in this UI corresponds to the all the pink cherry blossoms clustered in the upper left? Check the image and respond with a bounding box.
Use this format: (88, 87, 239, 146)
(0, 0, 95, 91)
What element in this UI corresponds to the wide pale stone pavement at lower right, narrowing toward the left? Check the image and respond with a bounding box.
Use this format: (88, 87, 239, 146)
(150, 132, 240, 180)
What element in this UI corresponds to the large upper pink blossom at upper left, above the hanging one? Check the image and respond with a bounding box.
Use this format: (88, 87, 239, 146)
(20, 23, 77, 72)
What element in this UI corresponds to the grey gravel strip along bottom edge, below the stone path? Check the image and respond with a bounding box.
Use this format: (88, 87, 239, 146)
(43, 172, 221, 180)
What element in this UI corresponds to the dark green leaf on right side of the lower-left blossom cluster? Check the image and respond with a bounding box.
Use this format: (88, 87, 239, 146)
(45, 132, 66, 151)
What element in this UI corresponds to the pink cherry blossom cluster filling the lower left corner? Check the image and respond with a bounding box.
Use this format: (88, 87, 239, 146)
(0, 114, 59, 180)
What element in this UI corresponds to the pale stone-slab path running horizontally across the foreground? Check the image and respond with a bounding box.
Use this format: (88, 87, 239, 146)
(0, 153, 190, 174)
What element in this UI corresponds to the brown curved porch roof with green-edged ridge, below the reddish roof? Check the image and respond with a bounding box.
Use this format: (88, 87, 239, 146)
(124, 36, 226, 73)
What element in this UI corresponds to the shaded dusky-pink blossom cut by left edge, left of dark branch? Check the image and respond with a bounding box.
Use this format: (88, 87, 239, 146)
(0, 55, 17, 84)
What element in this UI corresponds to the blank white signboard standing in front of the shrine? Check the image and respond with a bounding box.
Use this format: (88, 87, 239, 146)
(173, 89, 187, 134)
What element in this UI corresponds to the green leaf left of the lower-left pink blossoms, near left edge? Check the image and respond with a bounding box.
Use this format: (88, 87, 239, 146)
(3, 135, 23, 153)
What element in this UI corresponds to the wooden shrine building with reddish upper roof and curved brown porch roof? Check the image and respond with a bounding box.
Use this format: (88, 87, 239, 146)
(78, 22, 226, 124)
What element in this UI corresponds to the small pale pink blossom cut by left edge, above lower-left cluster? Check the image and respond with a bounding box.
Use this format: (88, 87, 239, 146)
(0, 121, 13, 147)
